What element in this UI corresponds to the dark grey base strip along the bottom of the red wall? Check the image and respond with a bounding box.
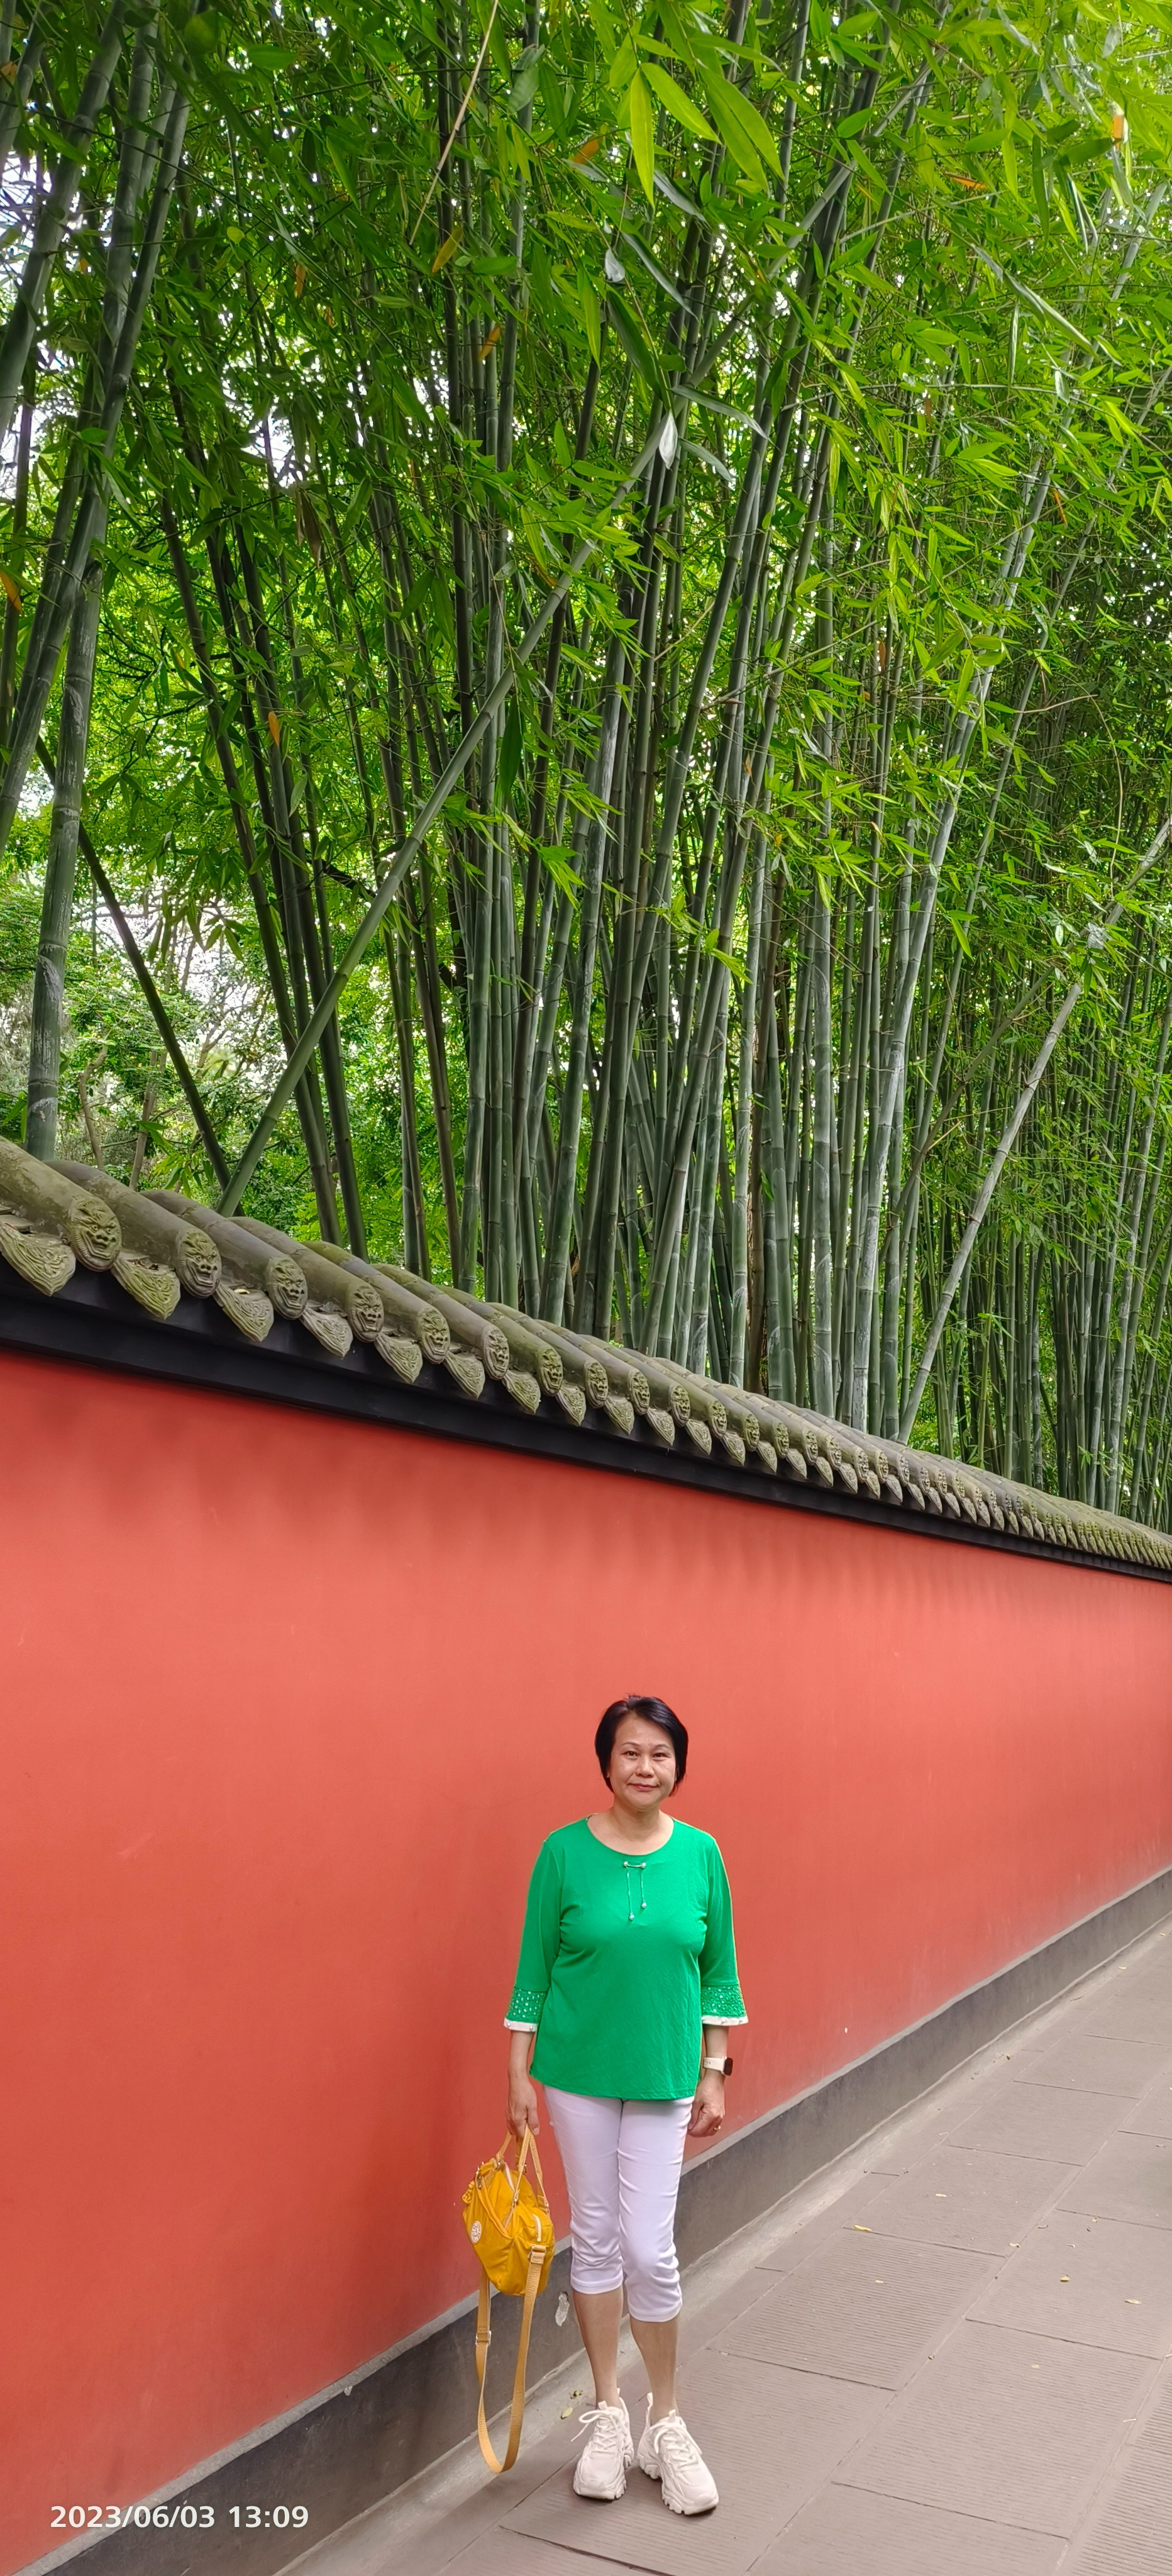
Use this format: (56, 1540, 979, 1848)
(26, 1870, 1172, 2576)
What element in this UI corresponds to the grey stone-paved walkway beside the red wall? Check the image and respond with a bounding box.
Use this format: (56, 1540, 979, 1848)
(284, 1927, 1172, 2576)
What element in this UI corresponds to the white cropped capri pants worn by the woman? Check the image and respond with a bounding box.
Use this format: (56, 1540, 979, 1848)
(546, 2084, 693, 2326)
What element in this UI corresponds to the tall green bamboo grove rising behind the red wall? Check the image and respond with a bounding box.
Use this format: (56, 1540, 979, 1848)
(0, 0, 1172, 1523)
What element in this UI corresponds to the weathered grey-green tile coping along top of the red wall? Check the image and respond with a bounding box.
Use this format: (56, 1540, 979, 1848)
(0, 1138, 1172, 1577)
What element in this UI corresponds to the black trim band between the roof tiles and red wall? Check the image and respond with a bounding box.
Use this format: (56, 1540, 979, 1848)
(0, 1262, 1172, 1584)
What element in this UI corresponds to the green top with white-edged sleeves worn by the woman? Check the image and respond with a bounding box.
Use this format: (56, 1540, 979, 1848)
(505, 1816, 747, 2102)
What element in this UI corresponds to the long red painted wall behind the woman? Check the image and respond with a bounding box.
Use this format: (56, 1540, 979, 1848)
(0, 1358, 1172, 2571)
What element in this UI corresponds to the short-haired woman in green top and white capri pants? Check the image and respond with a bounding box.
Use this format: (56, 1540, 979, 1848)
(505, 1692, 744, 2514)
